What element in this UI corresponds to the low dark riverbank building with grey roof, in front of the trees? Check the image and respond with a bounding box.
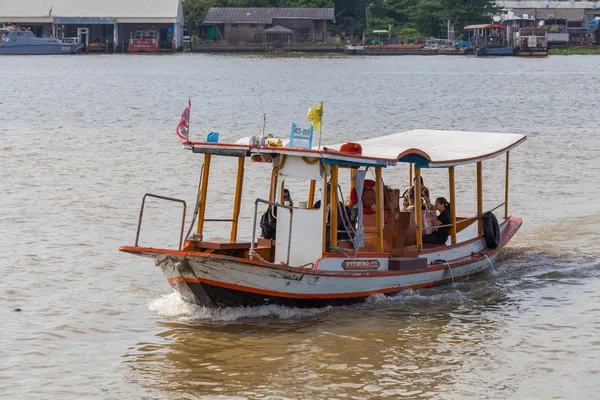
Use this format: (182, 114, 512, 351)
(202, 7, 335, 45)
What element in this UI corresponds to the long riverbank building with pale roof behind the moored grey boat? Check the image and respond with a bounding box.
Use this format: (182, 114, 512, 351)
(0, 0, 184, 52)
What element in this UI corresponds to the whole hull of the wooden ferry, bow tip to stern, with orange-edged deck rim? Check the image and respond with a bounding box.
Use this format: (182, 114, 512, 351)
(120, 217, 522, 307)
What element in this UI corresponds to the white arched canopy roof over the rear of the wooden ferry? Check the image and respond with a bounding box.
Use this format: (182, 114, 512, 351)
(327, 129, 527, 168)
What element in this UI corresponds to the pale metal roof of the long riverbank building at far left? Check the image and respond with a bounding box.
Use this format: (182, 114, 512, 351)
(0, 0, 181, 20)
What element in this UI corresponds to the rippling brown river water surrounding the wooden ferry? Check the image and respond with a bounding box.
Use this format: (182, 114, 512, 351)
(0, 55, 600, 399)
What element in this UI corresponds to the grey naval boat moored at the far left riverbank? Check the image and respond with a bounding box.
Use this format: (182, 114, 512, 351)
(0, 30, 83, 55)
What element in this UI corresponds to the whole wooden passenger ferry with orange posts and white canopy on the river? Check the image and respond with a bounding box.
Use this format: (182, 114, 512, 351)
(120, 130, 526, 307)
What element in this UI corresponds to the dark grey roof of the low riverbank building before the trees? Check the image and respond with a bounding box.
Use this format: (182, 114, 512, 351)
(204, 7, 335, 24)
